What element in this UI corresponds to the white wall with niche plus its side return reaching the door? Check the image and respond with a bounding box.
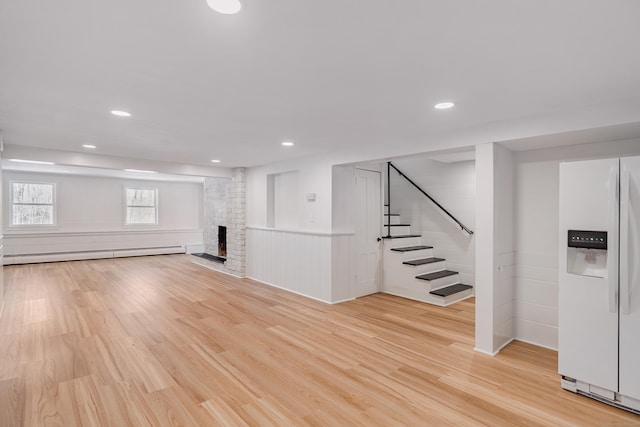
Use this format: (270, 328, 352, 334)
(247, 156, 370, 302)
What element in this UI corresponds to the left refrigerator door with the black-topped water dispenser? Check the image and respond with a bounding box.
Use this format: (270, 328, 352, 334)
(558, 159, 619, 391)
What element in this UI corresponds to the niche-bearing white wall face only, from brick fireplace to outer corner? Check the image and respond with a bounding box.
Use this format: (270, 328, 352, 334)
(246, 156, 332, 302)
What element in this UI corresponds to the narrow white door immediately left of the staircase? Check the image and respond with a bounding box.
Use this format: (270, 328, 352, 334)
(355, 169, 382, 298)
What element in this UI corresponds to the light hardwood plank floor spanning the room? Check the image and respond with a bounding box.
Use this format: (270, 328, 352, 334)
(0, 255, 640, 427)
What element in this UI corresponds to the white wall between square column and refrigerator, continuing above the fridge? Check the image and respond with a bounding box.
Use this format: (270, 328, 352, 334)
(514, 140, 640, 349)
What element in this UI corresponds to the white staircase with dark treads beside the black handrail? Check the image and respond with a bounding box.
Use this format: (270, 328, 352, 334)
(382, 205, 473, 306)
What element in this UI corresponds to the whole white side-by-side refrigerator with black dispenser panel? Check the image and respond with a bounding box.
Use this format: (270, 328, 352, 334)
(558, 157, 640, 413)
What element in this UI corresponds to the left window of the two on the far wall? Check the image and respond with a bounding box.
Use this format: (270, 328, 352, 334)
(11, 182, 56, 225)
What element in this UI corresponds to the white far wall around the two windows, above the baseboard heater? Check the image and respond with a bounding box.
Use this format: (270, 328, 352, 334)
(3, 171, 203, 255)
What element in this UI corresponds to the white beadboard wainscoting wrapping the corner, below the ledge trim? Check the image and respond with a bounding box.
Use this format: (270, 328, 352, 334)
(247, 227, 353, 303)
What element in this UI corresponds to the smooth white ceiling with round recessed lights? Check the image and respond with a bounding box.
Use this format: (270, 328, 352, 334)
(0, 0, 640, 167)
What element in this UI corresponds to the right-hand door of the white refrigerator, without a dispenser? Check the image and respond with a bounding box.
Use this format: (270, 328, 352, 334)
(620, 157, 640, 400)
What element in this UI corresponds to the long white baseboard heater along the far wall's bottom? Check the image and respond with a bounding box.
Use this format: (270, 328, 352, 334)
(3, 246, 186, 265)
